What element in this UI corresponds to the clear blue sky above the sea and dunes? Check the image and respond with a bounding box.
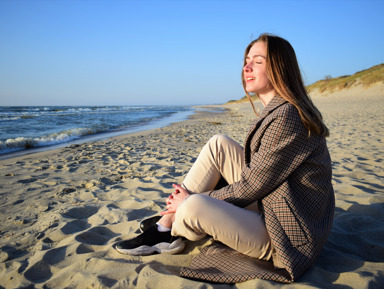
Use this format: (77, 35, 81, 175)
(0, 0, 384, 105)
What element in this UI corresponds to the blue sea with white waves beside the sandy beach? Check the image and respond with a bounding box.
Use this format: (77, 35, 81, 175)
(0, 105, 194, 158)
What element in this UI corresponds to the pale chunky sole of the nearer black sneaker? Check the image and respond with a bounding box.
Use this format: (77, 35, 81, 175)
(116, 238, 185, 256)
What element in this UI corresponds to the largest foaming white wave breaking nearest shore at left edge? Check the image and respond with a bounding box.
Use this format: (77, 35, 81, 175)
(0, 128, 100, 154)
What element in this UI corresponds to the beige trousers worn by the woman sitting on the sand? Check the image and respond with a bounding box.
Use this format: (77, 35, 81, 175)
(172, 135, 272, 260)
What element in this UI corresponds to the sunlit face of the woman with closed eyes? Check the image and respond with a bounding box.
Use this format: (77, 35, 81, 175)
(243, 41, 274, 96)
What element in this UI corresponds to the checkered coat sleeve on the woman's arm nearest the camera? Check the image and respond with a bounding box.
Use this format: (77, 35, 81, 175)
(209, 105, 315, 207)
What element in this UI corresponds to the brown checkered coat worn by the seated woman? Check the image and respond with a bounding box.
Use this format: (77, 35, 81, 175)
(181, 96, 335, 283)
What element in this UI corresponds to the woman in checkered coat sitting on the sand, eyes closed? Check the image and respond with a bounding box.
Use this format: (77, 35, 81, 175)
(117, 34, 335, 283)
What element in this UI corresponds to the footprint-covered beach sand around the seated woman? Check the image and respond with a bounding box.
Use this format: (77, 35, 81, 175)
(0, 86, 384, 289)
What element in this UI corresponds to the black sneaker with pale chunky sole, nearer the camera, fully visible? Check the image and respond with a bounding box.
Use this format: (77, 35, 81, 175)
(116, 225, 185, 256)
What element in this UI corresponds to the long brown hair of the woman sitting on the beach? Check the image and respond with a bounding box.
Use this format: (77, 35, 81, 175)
(241, 33, 329, 137)
